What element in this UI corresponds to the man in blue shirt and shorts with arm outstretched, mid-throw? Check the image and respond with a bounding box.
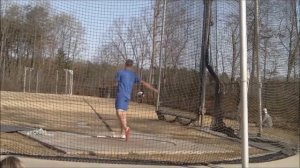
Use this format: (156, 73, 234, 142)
(115, 59, 158, 141)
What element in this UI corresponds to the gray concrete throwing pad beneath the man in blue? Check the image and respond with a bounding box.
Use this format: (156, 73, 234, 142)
(21, 131, 231, 155)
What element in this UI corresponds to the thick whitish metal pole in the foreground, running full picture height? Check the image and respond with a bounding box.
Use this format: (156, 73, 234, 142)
(240, 0, 249, 168)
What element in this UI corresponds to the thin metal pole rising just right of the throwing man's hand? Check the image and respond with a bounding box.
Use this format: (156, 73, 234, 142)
(156, 0, 167, 111)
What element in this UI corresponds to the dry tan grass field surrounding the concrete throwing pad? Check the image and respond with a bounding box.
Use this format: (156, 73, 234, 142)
(0, 91, 299, 162)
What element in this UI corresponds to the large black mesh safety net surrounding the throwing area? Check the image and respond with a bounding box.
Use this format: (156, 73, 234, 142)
(0, 0, 300, 163)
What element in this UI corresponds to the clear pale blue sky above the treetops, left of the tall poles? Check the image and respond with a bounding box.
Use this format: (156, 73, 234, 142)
(11, 0, 153, 59)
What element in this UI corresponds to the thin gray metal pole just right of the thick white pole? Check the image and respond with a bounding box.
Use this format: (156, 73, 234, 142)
(255, 0, 262, 136)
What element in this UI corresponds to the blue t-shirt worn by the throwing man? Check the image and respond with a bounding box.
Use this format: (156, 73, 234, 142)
(116, 69, 140, 100)
